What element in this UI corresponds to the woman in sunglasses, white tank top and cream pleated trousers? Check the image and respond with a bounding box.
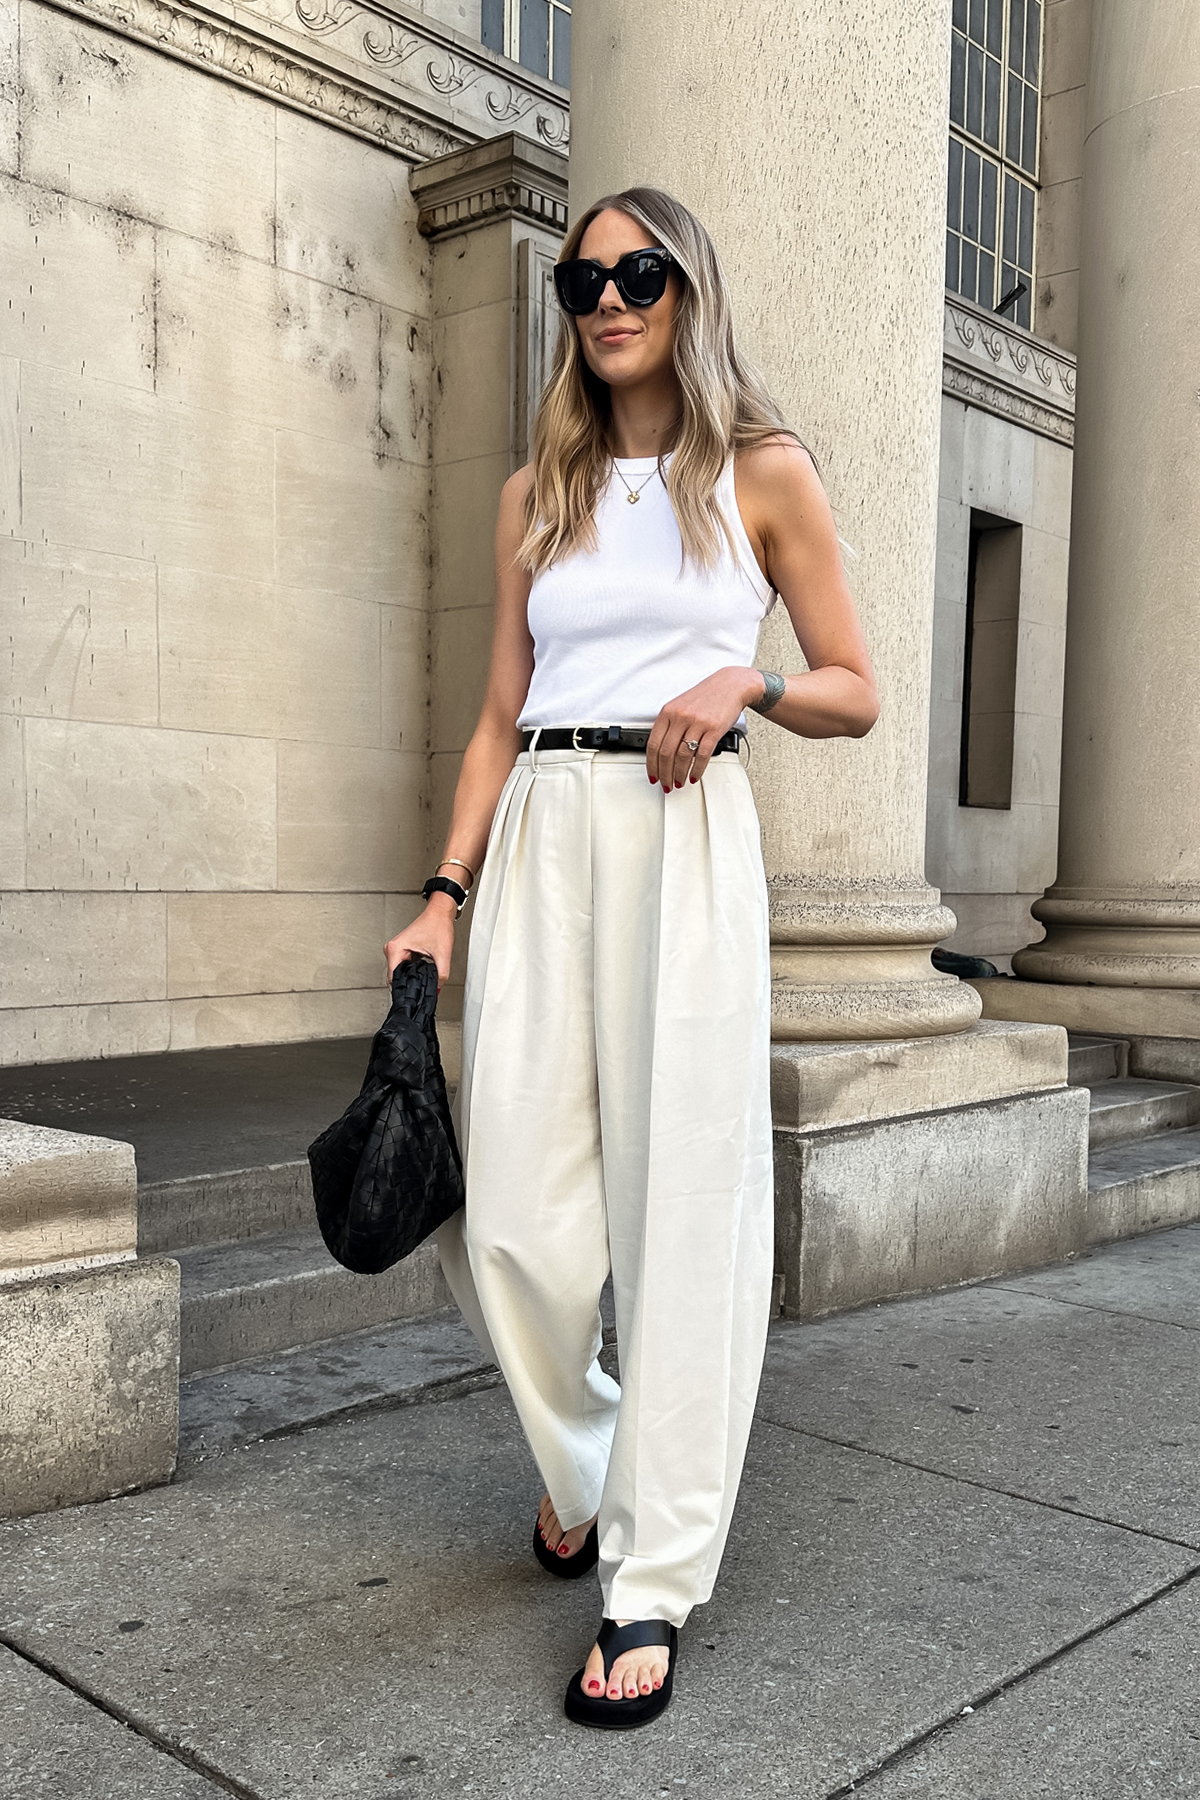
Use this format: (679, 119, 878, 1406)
(387, 187, 878, 1728)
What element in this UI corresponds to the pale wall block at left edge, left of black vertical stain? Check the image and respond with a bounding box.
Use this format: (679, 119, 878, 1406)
(0, 180, 155, 389)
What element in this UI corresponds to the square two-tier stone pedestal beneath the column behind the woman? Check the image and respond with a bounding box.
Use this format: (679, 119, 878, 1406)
(772, 1022, 1088, 1318)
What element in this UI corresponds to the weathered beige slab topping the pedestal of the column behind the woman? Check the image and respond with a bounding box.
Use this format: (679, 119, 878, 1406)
(770, 1021, 1067, 1132)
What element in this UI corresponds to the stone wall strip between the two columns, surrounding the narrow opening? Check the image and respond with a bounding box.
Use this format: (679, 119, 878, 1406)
(927, 297, 1074, 968)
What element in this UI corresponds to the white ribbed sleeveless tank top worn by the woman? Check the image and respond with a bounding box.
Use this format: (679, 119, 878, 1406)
(516, 457, 775, 729)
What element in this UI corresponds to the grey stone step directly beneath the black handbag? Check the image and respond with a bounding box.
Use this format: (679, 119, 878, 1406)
(176, 1228, 450, 1377)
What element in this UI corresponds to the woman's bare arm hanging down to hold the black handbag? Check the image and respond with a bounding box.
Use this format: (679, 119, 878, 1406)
(383, 468, 533, 986)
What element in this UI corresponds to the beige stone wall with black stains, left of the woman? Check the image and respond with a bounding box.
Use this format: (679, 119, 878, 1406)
(0, 0, 565, 1062)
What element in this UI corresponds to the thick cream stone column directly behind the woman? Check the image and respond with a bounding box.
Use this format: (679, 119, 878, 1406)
(570, 0, 979, 1039)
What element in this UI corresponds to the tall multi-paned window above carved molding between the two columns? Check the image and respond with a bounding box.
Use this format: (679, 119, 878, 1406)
(946, 0, 1042, 329)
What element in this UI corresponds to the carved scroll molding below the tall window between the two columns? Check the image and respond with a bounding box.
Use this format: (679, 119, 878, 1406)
(941, 295, 1076, 445)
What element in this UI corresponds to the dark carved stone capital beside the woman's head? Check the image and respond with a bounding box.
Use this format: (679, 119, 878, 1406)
(408, 131, 567, 238)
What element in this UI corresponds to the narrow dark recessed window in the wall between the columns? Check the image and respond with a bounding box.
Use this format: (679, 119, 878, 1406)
(959, 509, 1020, 808)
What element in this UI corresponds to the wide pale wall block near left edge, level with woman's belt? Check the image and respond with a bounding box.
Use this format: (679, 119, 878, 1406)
(25, 718, 275, 889)
